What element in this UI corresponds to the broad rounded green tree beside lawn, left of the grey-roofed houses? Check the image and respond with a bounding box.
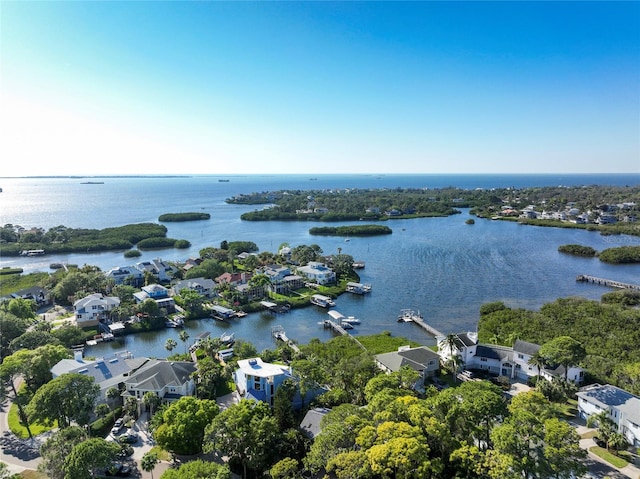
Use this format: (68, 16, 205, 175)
(27, 373, 100, 428)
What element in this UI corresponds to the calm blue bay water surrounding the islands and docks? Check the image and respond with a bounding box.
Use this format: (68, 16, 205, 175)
(0, 175, 640, 357)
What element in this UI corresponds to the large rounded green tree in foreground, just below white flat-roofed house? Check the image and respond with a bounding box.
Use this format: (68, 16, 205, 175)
(205, 399, 278, 479)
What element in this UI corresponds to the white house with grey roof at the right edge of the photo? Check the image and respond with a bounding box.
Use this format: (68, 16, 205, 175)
(576, 384, 640, 447)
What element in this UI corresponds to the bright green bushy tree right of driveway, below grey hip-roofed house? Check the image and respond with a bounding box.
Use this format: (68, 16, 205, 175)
(154, 396, 219, 454)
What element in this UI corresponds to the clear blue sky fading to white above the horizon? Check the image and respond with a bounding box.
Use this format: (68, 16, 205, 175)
(0, 1, 640, 176)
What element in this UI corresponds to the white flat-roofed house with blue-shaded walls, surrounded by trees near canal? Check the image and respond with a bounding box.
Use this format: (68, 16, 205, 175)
(233, 358, 293, 406)
